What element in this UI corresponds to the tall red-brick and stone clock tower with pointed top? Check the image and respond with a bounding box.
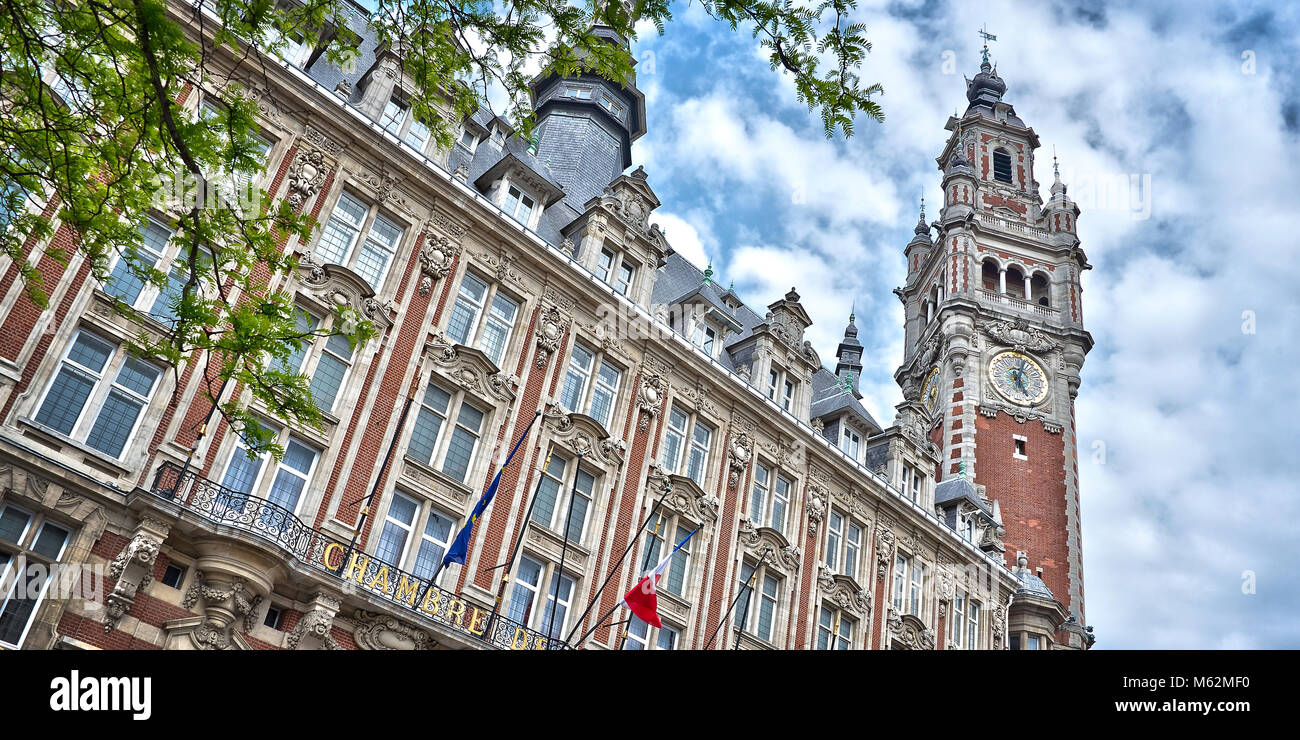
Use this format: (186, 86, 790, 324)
(894, 36, 1092, 646)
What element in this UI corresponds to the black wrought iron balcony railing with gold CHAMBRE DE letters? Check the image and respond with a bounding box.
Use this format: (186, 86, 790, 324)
(151, 463, 563, 650)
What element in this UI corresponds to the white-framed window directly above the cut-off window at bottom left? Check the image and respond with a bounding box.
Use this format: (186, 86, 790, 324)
(35, 330, 163, 458)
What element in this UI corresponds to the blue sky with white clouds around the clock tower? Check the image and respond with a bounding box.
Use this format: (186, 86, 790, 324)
(624, 0, 1300, 648)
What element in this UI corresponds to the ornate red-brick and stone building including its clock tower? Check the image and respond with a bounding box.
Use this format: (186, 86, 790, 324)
(0, 8, 1092, 649)
